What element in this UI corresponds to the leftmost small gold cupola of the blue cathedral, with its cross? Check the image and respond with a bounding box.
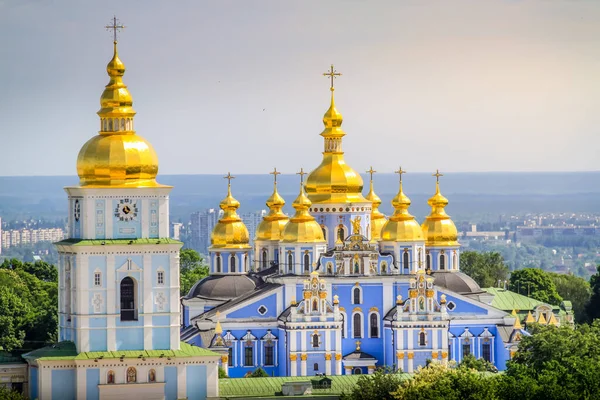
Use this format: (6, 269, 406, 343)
(210, 173, 250, 250)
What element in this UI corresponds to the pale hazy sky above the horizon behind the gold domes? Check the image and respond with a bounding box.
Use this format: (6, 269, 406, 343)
(0, 0, 600, 176)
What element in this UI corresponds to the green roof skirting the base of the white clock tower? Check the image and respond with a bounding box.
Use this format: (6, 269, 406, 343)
(23, 342, 218, 361)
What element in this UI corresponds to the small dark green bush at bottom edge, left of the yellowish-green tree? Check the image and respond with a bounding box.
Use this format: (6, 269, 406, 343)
(340, 370, 402, 400)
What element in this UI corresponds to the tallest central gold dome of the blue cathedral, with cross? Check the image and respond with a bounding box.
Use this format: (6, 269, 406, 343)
(306, 65, 367, 204)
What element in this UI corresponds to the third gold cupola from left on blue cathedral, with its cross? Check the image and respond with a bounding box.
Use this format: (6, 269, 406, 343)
(282, 169, 325, 243)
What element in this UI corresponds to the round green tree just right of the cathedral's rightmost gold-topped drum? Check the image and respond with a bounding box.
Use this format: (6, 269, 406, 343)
(460, 251, 508, 287)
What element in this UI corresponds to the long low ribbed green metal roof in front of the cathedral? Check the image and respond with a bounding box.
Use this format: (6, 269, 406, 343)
(219, 373, 410, 397)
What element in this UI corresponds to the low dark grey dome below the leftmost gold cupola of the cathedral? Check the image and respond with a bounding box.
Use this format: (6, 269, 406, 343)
(186, 275, 256, 300)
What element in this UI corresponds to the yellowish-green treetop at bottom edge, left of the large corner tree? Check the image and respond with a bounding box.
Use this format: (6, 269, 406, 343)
(394, 363, 500, 400)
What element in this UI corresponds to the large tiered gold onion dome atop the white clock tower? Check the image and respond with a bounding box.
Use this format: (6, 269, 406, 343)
(77, 41, 161, 187)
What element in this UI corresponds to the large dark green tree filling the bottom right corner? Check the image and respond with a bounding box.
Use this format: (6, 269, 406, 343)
(498, 321, 600, 400)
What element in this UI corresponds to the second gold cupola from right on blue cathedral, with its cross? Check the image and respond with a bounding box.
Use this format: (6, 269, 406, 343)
(381, 168, 424, 242)
